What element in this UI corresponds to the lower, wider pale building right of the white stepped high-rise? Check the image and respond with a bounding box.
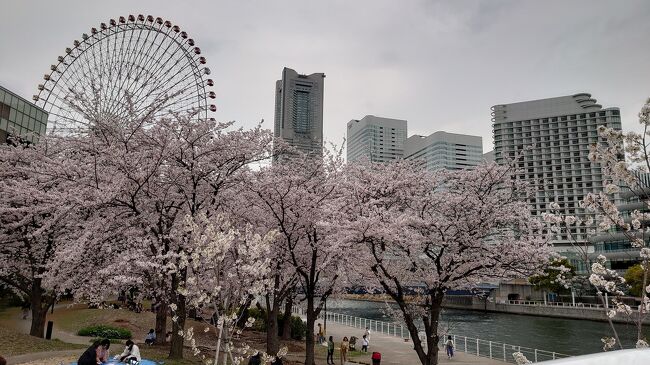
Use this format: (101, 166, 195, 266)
(404, 131, 483, 170)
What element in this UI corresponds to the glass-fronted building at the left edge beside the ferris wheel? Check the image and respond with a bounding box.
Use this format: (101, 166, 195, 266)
(0, 86, 48, 143)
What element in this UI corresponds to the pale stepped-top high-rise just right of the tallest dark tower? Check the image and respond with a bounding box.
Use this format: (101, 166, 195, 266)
(347, 115, 407, 162)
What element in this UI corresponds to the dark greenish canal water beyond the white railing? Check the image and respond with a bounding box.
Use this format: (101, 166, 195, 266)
(327, 299, 650, 355)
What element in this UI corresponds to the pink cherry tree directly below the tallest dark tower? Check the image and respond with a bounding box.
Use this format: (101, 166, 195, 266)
(251, 151, 349, 365)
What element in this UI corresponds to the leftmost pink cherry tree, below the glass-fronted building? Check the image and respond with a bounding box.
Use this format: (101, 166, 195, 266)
(0, 137, 100, 337)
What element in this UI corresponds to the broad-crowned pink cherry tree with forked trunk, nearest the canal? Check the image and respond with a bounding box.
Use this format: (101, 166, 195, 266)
(337, 161, 551, 365)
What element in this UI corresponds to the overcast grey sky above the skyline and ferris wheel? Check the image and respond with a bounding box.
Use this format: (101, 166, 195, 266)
(0, 0, 650, 151)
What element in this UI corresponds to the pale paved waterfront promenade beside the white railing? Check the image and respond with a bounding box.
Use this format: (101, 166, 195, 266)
(303, 317, 506, 365)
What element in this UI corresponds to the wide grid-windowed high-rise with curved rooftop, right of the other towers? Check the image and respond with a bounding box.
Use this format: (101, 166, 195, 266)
(492, 93, 621, 247)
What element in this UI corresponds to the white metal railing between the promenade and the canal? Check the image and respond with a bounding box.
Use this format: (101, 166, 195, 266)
(293, 306, 570, 364)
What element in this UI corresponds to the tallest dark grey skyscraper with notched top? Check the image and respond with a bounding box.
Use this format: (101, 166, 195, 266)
(274, 67, 325, 155)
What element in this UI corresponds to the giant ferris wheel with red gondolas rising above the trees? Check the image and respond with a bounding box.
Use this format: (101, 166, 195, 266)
(34, 15, 216, 134)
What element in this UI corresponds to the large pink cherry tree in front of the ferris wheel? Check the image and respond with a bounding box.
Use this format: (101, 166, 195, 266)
(37, 98, 271, 358)
